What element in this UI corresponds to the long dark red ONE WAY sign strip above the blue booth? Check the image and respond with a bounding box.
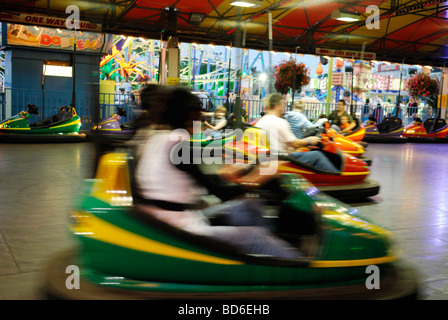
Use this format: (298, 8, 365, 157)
(0, 12, 102, 32)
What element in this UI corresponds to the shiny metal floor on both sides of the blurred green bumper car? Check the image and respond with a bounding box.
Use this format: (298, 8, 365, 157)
(0, 143, 448, 300)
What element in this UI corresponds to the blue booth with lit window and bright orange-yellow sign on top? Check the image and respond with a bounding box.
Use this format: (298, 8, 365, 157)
(0, 23, 108, 128)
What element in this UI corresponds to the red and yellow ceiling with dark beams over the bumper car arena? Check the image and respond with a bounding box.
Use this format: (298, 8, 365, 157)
(0, 0, 448, 66)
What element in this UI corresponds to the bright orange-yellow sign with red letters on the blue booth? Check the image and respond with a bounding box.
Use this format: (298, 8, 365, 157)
(7, 23, 104, 52)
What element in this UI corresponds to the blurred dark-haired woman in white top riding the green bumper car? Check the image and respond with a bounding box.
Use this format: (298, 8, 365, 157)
(135, 87, 301, 258)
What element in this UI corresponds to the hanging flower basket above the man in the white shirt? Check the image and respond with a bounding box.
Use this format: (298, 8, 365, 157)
(274, 59, 311, 94)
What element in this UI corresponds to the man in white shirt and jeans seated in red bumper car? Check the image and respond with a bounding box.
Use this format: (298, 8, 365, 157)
(256, 93, 339, 172)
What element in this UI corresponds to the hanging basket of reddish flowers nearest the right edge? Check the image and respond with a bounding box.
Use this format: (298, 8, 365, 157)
(408, 73, 439, 108)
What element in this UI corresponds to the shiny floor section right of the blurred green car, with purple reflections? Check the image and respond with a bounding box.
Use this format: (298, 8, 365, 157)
(352, 143, 448, 300)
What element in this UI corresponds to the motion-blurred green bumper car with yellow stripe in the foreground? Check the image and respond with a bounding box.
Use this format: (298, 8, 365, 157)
(45, 152, 417, 299)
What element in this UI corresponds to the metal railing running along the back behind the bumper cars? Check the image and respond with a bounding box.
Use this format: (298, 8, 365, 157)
(0, 89, 440, 130)
